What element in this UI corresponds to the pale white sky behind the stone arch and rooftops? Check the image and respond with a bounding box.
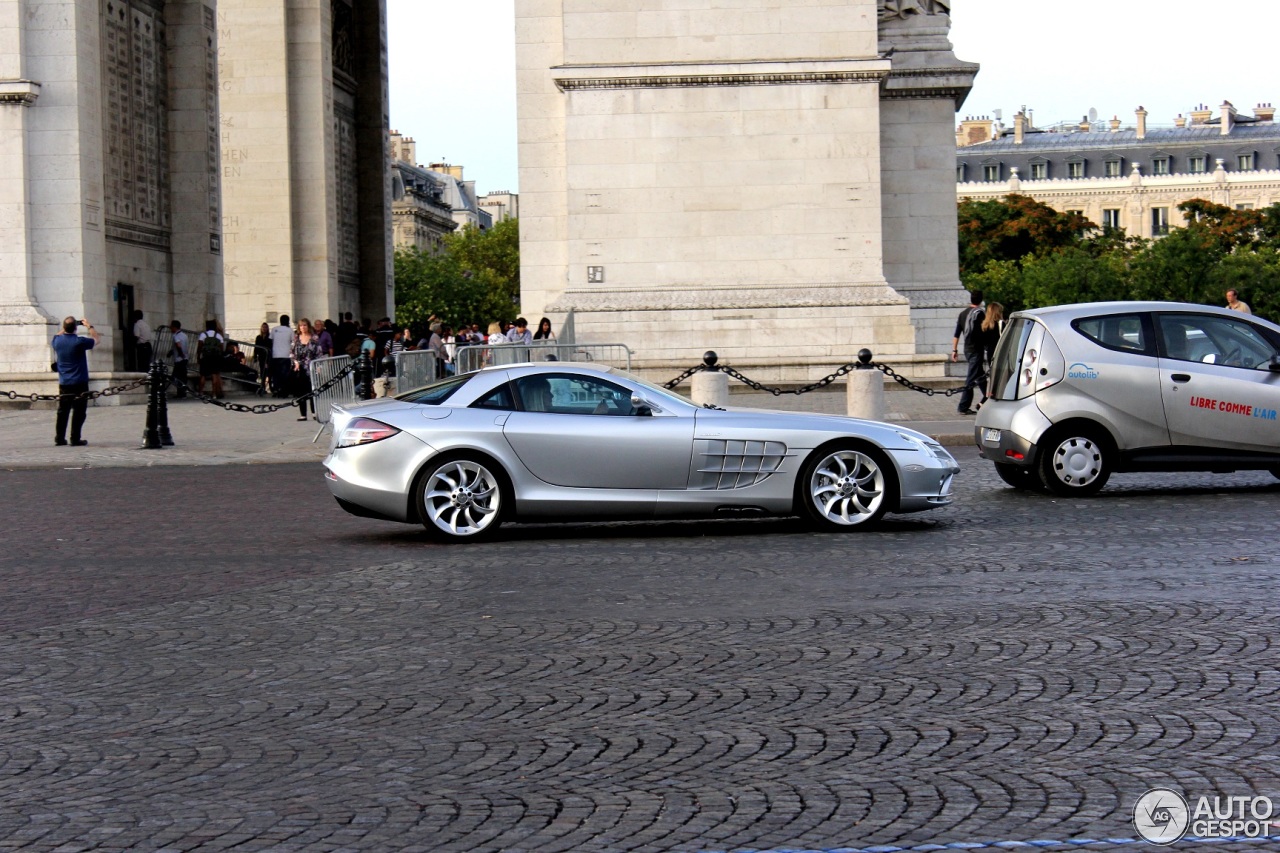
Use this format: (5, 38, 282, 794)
(387, 0, 1280, 192)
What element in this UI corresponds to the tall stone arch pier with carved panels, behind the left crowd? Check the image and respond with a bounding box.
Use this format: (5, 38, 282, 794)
(0, 0, 392, 387)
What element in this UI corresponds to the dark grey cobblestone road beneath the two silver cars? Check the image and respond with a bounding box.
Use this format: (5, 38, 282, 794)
(0, 451, 1280, 853)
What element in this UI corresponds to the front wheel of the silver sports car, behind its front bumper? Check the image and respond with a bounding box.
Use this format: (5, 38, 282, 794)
(796, 443, 899, 532)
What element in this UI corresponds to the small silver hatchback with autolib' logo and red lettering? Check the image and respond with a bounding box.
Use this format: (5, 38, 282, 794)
(974, 302, 1280, 496)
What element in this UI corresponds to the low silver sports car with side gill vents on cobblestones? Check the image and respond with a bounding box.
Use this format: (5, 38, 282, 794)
(324, 362, 960, 540)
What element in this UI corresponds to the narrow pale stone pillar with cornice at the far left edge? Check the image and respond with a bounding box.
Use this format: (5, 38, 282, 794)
(0, 0, 56, 373)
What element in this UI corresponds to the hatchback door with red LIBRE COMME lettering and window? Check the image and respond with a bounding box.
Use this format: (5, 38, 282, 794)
(1156, 311, 1280, 452)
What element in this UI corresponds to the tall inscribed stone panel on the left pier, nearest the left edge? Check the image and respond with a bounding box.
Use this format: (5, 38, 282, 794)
(102, 0, 170, 250)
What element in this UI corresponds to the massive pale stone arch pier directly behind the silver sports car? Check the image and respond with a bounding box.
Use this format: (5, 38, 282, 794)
(516, 0, 977, 379)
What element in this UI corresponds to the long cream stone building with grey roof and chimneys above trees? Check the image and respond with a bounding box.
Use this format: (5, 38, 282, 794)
(956, 102, 1280, 237)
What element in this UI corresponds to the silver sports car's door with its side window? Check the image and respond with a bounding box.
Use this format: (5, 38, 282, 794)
(503, 371, 694, 489)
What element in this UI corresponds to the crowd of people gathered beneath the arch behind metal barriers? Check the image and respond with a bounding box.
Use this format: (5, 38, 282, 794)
(120, 311, 556, 420)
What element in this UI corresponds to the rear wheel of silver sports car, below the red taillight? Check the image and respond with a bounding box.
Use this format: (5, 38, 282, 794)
(417, 453, 509, 542)
